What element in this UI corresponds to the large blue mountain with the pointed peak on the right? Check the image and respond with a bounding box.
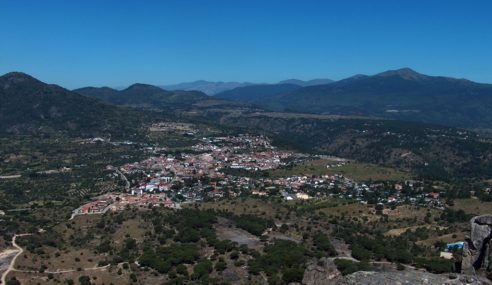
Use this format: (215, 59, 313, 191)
(216, 68, 492, 129)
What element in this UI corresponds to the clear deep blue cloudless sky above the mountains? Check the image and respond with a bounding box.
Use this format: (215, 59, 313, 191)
(0, 0, 492, 88)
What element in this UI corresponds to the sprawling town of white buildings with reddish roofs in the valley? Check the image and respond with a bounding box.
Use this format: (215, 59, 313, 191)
(73, 134, 444, 215)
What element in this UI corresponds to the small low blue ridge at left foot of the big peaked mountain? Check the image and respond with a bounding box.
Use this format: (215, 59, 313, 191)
(215, 84, 302, 105)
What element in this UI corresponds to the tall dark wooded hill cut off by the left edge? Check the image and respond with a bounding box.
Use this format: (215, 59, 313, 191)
(0, 72, 149, 135)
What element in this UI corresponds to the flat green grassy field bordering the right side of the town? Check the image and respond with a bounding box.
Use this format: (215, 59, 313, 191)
(270, 159, 411, 181)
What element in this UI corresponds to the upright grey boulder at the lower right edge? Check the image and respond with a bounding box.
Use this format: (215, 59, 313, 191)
(461, 215, 492, 274)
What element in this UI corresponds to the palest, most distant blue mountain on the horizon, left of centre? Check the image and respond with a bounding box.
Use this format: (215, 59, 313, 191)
(160, 80, 252, 96)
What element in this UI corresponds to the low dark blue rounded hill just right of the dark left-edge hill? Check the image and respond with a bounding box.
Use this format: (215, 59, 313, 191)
(74, 83, 209, 108)
